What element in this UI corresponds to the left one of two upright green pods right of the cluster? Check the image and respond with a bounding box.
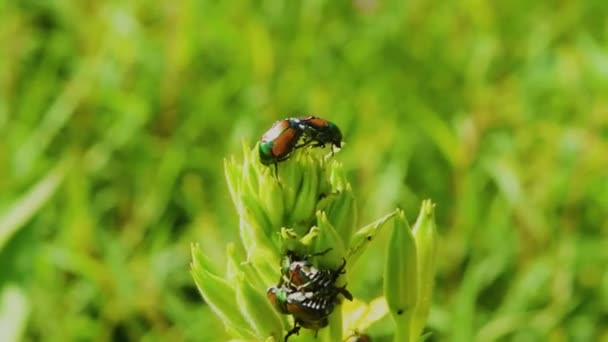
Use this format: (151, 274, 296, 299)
(384, 210, 418, 341)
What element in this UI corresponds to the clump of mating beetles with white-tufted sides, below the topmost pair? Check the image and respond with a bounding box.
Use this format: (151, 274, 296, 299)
(267, 249, 353, 341)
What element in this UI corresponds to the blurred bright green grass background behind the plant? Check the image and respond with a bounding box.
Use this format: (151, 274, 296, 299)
(0, 0, 608, 341)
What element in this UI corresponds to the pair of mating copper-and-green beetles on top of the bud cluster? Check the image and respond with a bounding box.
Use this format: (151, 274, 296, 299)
(259, 116, 342, 174)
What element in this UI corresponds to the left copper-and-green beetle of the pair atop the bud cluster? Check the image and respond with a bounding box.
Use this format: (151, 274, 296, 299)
(259, 118, 304, 175)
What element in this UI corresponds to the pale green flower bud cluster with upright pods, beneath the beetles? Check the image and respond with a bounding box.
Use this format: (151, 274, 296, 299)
(192, 146, 436, 341)
